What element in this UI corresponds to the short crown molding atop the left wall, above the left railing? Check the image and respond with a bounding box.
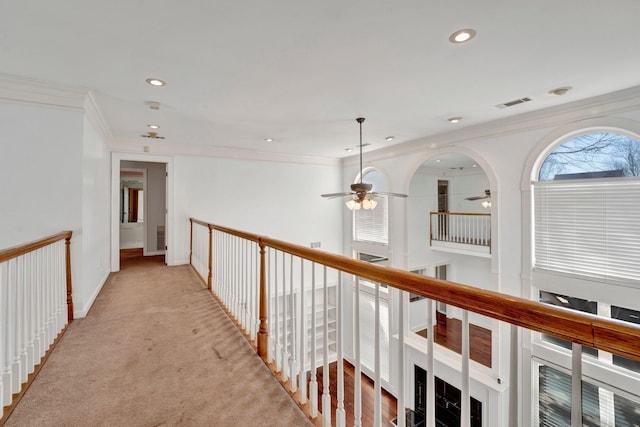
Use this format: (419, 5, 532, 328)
(0, 74, 89, 110)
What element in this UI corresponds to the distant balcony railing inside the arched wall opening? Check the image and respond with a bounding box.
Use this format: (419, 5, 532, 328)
(429, 212, 491, 251)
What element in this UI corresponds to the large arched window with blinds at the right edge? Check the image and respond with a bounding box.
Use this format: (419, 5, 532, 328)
(534, 132, 640, 286)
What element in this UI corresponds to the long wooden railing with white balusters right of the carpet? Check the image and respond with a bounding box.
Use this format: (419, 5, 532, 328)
(190, 218, 640, 426)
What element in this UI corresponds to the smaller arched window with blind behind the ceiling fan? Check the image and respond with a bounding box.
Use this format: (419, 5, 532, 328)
(353, 169, 389, 245)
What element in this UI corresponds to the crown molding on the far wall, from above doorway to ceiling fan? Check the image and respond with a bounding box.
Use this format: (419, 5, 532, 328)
(110, 139, 341, 166)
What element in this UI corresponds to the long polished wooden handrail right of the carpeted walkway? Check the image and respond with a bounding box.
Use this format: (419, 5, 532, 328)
(194, 219, 640, 361)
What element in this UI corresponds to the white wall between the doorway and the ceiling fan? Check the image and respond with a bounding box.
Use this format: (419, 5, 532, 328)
(173, 156, 344, 264)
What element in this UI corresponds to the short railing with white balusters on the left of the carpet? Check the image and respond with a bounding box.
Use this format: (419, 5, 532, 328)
(0, 231, 73, 424)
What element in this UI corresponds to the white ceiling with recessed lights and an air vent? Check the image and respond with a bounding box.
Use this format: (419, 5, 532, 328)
(0, 0, 640, 157)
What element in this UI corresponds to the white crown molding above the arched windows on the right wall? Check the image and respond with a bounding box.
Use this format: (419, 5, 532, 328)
(342, 86, 640, 166)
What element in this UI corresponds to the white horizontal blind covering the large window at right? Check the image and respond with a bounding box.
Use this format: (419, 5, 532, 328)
(534, 177, 640, 282)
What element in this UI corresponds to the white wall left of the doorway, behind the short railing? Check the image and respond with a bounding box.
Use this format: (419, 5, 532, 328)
(0, 98, 110, 317)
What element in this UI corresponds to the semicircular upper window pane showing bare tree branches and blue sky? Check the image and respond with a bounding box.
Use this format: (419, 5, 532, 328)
(539, 132, 640, 181)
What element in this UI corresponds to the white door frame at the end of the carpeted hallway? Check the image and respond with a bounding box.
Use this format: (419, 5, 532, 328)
(111, 153, 175, 272)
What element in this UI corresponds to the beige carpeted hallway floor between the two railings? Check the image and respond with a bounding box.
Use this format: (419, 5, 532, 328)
(6, 252, 311, 427)
